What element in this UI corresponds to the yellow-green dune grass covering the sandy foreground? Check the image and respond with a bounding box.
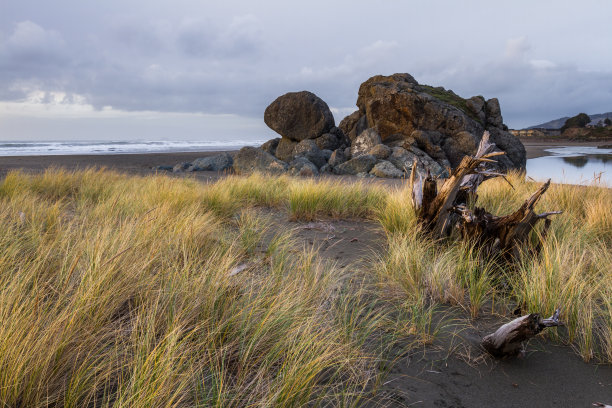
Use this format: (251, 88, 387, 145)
(0, 169, 612, 407)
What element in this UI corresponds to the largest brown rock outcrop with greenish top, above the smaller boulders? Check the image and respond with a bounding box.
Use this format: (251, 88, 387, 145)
(340, 74, 525, 169)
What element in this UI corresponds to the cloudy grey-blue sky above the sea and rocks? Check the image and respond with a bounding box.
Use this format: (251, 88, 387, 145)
(0, 0, 612, 141)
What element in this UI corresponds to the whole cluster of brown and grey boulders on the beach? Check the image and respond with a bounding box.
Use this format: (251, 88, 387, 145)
(160, 74, 526, 178)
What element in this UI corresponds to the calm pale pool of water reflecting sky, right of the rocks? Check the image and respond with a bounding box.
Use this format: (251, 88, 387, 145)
(527, 146, 612, 186)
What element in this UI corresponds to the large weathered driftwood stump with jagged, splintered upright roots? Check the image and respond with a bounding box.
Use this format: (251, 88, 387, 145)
(410, 131, 561, 257)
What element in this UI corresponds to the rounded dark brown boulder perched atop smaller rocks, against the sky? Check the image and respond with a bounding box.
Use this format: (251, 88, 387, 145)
(264, 91, 334, 142)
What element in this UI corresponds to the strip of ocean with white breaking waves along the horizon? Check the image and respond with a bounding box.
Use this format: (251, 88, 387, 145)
(0, 139, 265, 156)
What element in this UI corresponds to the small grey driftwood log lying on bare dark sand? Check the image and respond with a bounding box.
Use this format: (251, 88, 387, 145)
(481, 309, 563, 358)
